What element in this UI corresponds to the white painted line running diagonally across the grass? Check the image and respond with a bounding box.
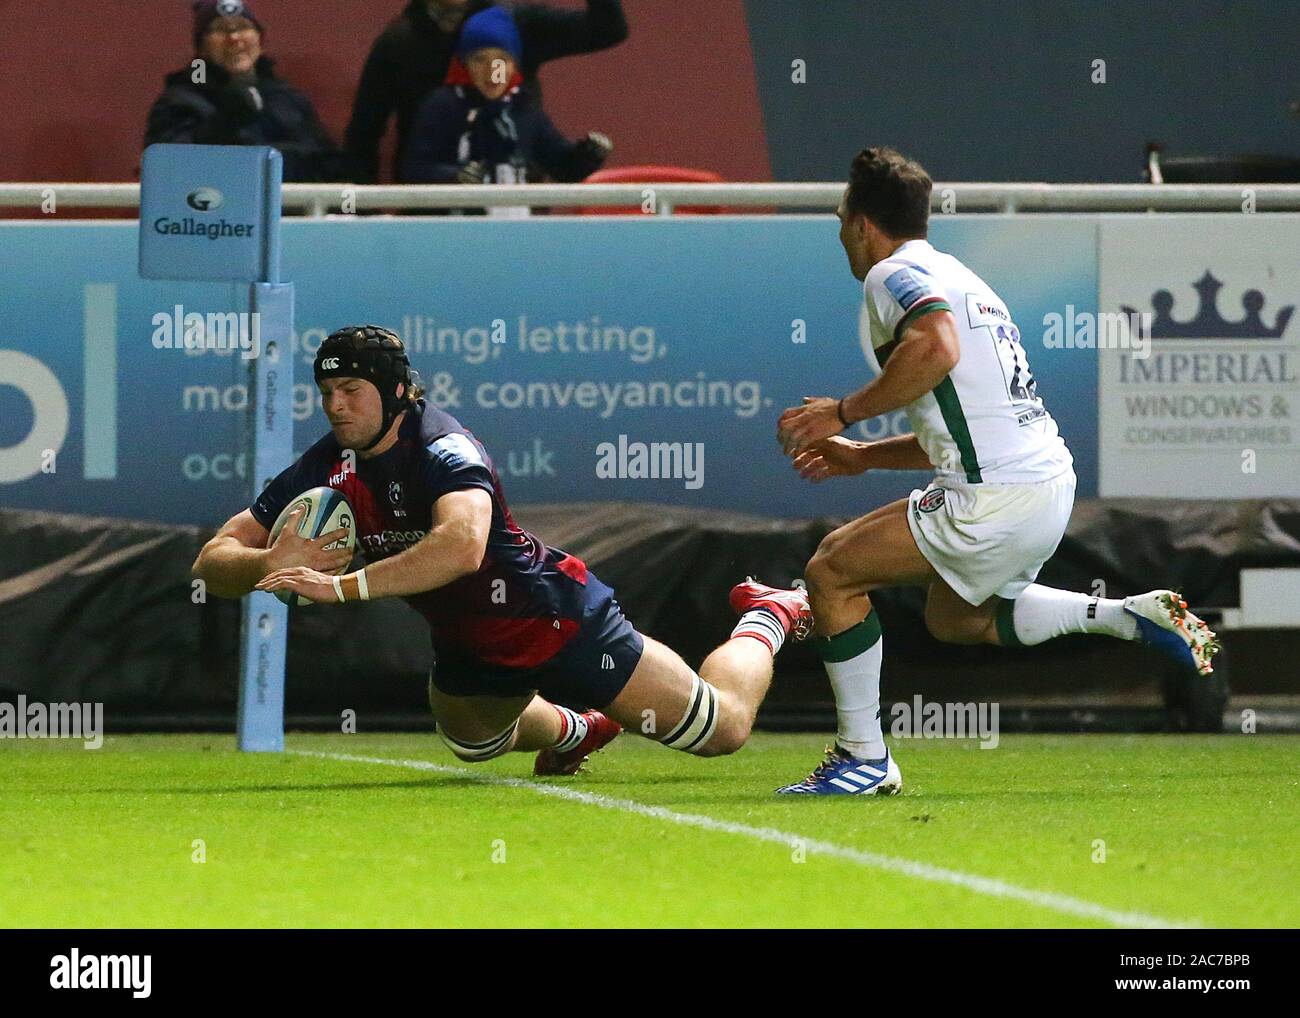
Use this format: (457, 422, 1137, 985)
(285, 749, 1196, 930)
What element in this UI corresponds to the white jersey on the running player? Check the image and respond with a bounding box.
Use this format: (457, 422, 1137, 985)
(863, 241, 1074, 484)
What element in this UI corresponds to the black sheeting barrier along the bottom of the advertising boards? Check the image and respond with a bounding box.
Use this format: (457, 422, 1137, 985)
(0, 499, 1300, 731)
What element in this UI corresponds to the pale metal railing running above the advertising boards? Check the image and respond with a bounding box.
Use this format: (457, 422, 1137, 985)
(0, 182, 1300, 216)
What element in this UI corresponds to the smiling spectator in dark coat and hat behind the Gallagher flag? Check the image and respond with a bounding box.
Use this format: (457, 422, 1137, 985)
(144, 0, 348, 181)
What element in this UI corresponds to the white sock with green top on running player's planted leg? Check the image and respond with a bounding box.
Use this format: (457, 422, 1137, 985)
(814, 610, 885, 761)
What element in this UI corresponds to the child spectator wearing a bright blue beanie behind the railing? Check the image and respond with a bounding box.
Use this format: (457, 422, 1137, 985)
(403, 7, 612, 193)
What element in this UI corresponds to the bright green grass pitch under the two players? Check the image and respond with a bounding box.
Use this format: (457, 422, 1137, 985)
(0, 735, 1300, 927)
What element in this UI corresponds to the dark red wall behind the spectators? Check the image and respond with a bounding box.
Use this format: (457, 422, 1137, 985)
(0, 0, 770, 181)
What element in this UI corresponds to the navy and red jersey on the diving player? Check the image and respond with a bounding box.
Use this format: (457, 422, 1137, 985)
(251, 399, 588, 668)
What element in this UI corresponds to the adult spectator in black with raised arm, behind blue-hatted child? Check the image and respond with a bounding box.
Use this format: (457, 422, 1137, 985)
(346, 0, 628, 183)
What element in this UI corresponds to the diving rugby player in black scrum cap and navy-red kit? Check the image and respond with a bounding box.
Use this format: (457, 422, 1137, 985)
(194, 326, 811, 774)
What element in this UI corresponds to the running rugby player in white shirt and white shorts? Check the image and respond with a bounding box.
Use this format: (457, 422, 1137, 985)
(777, 148, 1218, 794)
